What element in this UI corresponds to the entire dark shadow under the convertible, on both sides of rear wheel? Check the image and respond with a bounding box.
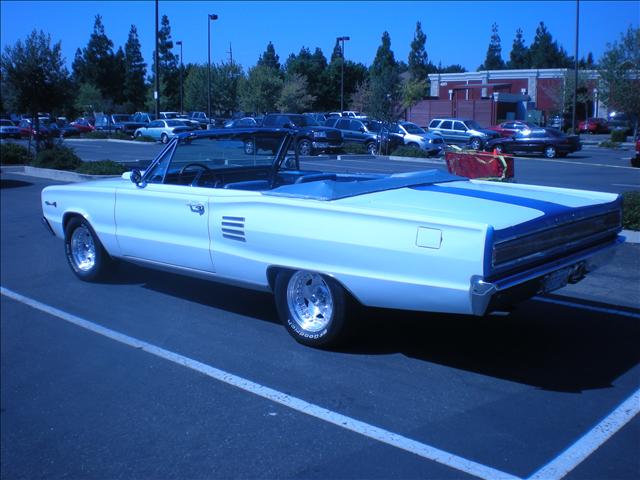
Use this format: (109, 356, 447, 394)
(105, 263, 640, 393)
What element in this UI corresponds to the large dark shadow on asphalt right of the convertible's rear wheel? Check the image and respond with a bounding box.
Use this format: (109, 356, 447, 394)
(343, 300, 640, 393)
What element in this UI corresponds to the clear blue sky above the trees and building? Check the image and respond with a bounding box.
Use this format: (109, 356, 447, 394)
(0, 0, 640, 70)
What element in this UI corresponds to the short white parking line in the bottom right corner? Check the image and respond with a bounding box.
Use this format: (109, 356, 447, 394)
(528, 389, 640, 480)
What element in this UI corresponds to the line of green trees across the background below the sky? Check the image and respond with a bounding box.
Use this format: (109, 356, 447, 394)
(0, 15, 638, 126)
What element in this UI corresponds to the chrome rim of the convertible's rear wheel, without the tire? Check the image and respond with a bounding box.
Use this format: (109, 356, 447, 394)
(287, 271, 334, 333)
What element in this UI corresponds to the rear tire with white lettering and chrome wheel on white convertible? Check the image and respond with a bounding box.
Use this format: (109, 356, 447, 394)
(274, 270, 350, 348)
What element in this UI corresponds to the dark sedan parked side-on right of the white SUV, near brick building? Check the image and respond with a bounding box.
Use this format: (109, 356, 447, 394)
(485, 128, 582, 158)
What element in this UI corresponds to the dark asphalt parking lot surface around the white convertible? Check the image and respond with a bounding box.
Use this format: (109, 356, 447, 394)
(0, 148, 640, 479)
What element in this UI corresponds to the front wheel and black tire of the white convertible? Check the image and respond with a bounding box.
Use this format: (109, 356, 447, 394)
(64, 217, 113, 282)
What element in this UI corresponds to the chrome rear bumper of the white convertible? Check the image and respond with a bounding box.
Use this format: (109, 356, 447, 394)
(470, 236, 625, 316)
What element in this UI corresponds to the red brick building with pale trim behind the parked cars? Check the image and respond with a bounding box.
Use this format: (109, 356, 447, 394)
(405, 68, 608, 126)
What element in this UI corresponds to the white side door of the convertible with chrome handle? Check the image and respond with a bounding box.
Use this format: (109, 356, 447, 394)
(114, 147, 214, 272)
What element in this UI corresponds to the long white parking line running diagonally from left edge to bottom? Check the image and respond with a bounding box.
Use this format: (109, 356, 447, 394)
(0, 287, 520, 480)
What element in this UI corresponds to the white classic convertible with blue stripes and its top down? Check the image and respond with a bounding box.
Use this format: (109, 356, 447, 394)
(42, 129, 622, 347)
